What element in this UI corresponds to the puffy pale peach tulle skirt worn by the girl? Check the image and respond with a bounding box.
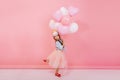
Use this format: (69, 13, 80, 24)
(47, 50, 67, 68)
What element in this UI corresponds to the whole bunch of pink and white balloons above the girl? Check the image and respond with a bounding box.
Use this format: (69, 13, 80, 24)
(49, 6, 79, 35)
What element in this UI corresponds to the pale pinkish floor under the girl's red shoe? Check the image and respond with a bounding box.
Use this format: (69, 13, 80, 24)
(0, 69, 120, 80)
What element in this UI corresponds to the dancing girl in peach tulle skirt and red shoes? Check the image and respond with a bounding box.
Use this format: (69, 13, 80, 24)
(43, 31, 67, 77)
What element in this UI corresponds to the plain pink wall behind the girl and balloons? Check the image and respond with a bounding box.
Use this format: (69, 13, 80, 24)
(0, 0, 120, 68)
